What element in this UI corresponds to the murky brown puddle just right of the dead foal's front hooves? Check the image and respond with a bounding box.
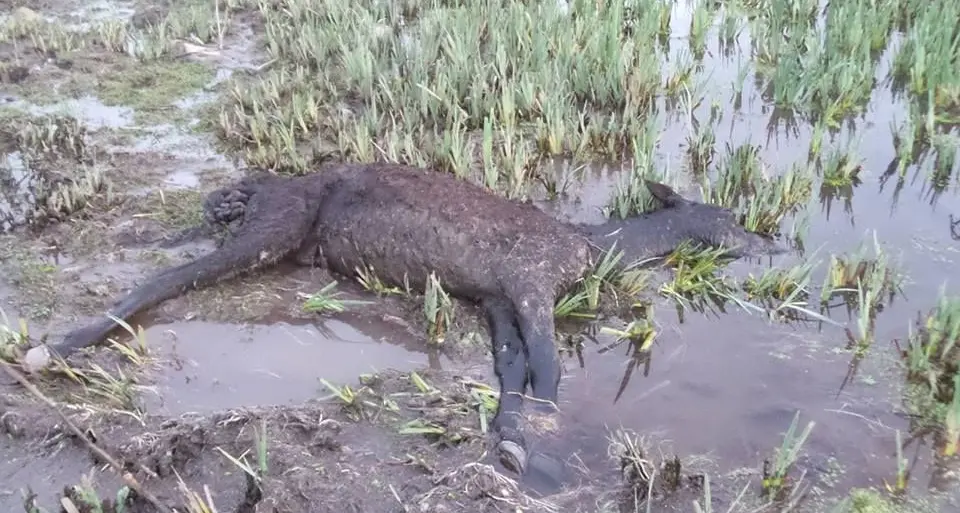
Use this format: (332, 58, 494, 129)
(542, 302, 906, 492)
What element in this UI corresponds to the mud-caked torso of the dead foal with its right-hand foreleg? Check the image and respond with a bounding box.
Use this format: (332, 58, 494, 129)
(301, 165, 595, 402)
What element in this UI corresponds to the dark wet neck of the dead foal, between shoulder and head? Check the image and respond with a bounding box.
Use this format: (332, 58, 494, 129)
(578, 211, 688, 265)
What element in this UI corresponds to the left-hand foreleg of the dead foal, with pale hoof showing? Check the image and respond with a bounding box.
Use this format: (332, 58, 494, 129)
(481, 298, 527, 474)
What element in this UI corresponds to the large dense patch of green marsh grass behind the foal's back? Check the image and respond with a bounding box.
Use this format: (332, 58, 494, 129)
(219, 0, 688, 177)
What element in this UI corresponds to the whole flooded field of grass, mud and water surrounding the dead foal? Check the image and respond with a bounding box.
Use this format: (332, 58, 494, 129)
(0, 0, 960, 513)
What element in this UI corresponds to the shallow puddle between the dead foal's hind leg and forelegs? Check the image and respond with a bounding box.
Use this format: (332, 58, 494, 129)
(144, 312, 449, 415)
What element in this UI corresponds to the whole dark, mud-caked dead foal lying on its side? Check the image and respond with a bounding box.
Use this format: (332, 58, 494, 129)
(30, 164, 776, 469)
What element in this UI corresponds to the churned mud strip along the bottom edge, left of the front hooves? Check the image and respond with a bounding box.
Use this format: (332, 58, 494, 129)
(0, 371, 628, 512)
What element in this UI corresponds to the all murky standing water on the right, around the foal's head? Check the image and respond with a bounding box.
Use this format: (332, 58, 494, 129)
(524, 4, 960, 498)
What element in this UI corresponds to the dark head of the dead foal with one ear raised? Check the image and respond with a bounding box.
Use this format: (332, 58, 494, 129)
(646, 180, 787, 257)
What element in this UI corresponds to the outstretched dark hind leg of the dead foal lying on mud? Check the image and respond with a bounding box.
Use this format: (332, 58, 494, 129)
(34, 183, 320, 362)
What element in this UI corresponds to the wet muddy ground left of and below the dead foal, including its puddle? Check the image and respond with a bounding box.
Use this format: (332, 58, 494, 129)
(0, 2, 656, 512)
